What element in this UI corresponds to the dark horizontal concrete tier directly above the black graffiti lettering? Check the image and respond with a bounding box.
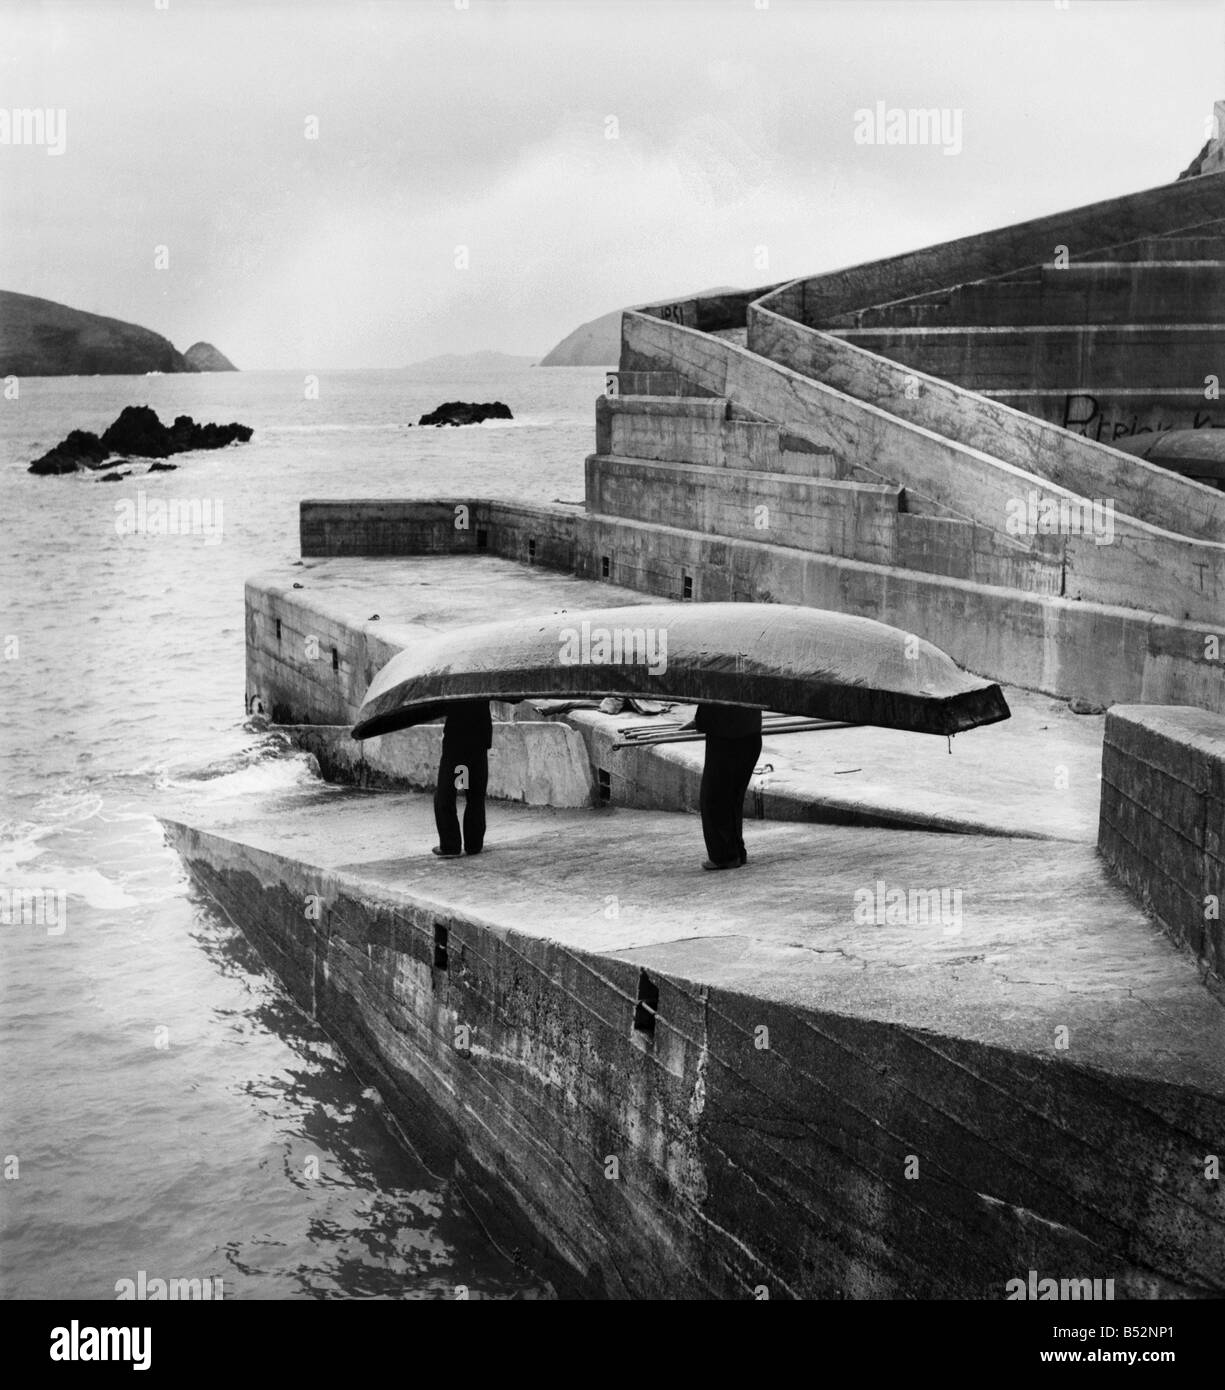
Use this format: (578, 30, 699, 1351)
(833, 322, 1225, 392)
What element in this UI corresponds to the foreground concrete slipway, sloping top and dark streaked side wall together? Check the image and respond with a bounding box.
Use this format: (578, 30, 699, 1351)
(157, 791, 1225, 1298)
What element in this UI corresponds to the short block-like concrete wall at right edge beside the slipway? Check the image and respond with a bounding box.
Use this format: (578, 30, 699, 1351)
(1097, 705, 1225, 998)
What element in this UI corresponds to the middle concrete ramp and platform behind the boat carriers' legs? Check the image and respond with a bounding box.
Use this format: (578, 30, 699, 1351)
(248, 556, 1103, 841)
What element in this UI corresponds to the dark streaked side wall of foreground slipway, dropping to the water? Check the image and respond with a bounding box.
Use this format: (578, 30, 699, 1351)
(167, 823, 1225, 1300)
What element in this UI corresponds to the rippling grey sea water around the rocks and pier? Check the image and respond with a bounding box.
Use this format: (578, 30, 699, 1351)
(0, 368, 603, 1300)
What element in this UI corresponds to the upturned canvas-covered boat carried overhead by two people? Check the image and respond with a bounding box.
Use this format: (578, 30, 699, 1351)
(353, 603, 1008, 738)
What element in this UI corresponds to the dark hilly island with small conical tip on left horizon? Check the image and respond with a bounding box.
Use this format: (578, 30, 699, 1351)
(0, 289, 236, 377)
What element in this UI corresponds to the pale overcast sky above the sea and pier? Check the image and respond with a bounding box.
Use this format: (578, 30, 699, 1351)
(0, 0, 1225, 368)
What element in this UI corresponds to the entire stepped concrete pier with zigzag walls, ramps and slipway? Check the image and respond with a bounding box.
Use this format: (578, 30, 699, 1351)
(164, 154, 1225, 1298)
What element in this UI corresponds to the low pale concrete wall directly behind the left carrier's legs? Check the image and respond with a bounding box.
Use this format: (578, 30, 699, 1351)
(285, 722, 598, 806)
